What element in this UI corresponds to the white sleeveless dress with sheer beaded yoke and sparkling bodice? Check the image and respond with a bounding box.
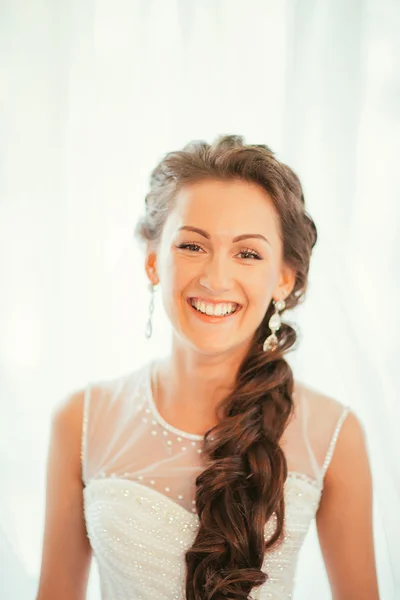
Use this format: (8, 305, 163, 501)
(82, 361, 349, 600)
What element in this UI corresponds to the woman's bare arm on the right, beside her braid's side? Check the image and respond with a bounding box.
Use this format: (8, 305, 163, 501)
(316, 412, 379, 600)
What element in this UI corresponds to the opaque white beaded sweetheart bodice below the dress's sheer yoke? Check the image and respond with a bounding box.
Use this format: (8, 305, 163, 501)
(84, 473, 320, 599)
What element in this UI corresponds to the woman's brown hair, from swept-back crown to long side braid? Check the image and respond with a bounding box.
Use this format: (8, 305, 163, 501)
(136, 135, 317, 600)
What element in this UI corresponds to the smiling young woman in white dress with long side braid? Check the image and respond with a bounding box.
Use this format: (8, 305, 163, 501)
(37, 136, 378, 600)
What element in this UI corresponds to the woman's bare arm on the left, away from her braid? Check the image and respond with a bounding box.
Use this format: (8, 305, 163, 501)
(37, 392, 91, 600)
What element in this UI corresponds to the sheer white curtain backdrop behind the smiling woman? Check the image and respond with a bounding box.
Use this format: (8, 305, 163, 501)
(0, 0, 400, 600)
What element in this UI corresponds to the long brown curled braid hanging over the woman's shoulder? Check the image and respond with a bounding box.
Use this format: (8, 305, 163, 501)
(186, 314, 296, 600)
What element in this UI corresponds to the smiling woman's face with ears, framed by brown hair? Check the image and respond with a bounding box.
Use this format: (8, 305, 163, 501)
(147, 180, 294, 355)
